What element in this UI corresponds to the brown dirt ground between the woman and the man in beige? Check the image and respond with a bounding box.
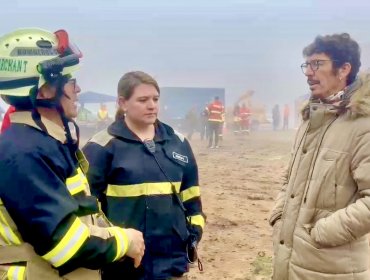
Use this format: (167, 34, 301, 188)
(186, 131, 295, 280)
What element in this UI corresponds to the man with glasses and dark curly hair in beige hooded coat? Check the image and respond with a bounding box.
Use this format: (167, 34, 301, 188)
(270, 34, 370, 280)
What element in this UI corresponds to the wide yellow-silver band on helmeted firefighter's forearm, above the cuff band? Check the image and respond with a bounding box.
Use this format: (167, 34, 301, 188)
(42, 218, 90, 267)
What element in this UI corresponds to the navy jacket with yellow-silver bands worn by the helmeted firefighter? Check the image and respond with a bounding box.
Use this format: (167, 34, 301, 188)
(0, 112, 132, 274)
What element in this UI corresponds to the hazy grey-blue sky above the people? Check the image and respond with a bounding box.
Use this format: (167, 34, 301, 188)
(0, 0, 370, 109)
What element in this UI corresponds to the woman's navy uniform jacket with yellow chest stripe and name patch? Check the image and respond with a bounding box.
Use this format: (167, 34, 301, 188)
(83, 120, 205, 279)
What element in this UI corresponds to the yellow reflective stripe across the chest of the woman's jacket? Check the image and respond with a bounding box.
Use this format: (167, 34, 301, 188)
(107, 182, 181, 197)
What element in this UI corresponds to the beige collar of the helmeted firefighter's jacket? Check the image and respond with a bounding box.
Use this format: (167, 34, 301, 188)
(10, 111, 67, 144)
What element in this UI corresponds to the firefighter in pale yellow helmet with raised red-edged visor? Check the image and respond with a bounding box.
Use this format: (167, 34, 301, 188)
(0, 29, 144, 280)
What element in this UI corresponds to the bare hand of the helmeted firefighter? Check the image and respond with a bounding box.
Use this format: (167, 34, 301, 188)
(125, 228, 145, 268)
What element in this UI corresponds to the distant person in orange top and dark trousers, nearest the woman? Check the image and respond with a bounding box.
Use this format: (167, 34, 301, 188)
(207, 96, 224, 149)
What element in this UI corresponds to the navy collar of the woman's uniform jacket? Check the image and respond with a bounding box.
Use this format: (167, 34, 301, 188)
(108, 119, 174, 142)
